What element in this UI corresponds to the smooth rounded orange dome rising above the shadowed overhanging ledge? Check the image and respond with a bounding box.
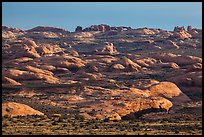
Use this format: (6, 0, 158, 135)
(149, 82, 182, 98)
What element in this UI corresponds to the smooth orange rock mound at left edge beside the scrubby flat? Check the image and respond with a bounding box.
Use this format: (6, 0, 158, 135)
(2, 102, 44, 117)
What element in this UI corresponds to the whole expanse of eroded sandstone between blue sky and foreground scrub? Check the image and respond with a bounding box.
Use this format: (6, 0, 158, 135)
(2, 24, 202, 120)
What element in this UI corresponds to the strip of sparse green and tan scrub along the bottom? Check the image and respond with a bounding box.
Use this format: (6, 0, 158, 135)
(2, 114, 202, 135)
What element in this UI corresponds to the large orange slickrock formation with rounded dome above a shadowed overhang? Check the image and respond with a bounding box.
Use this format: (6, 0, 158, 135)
(77, 82, 185, 120)
